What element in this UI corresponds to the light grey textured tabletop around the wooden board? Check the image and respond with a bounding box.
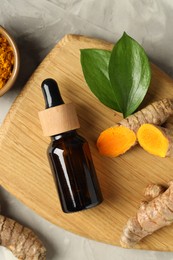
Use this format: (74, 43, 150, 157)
(0, 0, 173, 260)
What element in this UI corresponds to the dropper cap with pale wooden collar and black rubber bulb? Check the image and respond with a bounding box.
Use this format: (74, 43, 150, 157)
(39, 79, 80, 136)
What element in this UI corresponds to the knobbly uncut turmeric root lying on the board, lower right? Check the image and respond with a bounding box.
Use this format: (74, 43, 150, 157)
(120, 181, 173, 248)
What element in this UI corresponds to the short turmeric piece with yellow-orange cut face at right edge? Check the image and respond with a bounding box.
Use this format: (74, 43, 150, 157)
(137, 124, 173, 157)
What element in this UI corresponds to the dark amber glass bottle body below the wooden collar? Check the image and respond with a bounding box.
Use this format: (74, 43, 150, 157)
(48, 130, 102, 212)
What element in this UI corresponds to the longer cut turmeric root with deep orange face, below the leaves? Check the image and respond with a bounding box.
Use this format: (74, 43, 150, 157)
(97, 99, 173, 157)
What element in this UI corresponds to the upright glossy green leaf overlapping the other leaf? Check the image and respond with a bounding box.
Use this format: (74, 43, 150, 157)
(109, 33, 151, 117)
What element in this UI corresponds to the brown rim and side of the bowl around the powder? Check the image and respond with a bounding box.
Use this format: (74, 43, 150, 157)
(0, 26, 20, 96)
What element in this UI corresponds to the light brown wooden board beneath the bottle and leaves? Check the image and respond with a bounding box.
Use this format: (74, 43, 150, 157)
(0, 35, 173, 251)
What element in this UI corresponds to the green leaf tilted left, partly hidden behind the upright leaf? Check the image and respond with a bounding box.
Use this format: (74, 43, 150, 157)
(81, 49, 120, 111)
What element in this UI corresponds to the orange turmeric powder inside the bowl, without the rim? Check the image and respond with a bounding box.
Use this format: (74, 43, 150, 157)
(0, 34, 14, 89)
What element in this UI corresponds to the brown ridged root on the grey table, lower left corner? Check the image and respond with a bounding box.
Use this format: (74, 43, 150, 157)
(0, 215, 46, 260)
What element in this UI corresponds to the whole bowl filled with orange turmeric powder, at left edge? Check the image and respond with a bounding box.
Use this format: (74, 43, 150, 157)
(0, 26, 19, 96)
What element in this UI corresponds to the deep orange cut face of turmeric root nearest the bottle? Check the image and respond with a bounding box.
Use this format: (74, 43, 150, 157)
(97, 125, 136, 157)
